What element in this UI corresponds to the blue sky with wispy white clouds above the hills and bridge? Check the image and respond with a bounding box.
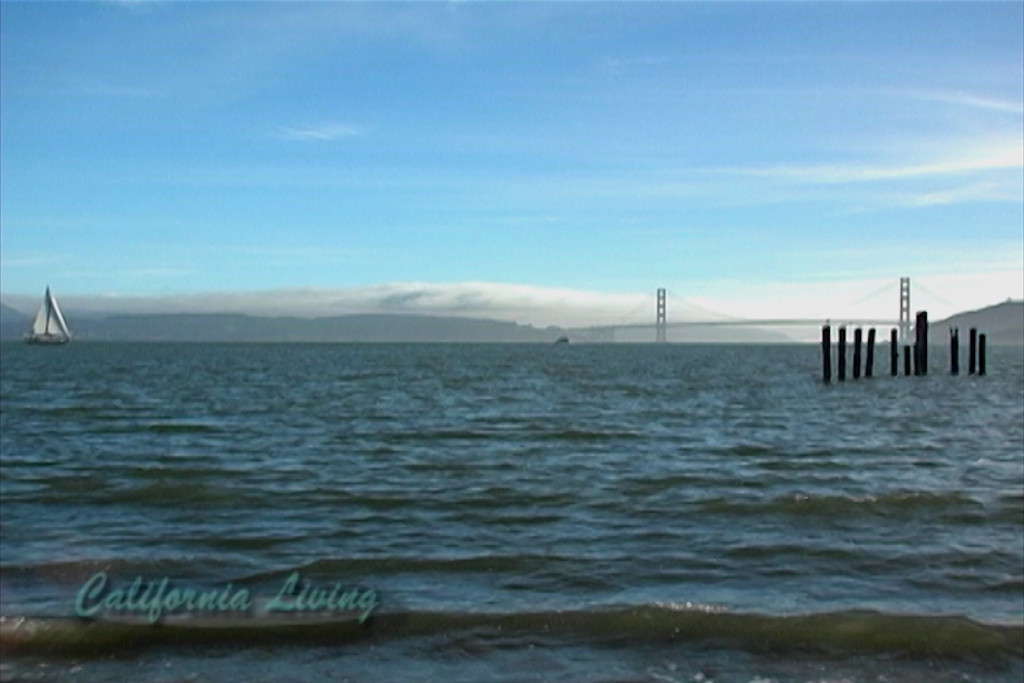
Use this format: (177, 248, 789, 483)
(0, 0, 1024, 326)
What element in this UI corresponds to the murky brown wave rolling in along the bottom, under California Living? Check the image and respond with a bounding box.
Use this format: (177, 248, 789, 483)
(0, 605, 1024, 663)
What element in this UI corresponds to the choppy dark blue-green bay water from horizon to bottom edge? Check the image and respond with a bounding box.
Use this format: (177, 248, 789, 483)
(0, 343, 1024, 683)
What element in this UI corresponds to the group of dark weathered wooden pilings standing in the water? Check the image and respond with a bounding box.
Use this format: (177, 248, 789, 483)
(821, 311, 985, 383)
